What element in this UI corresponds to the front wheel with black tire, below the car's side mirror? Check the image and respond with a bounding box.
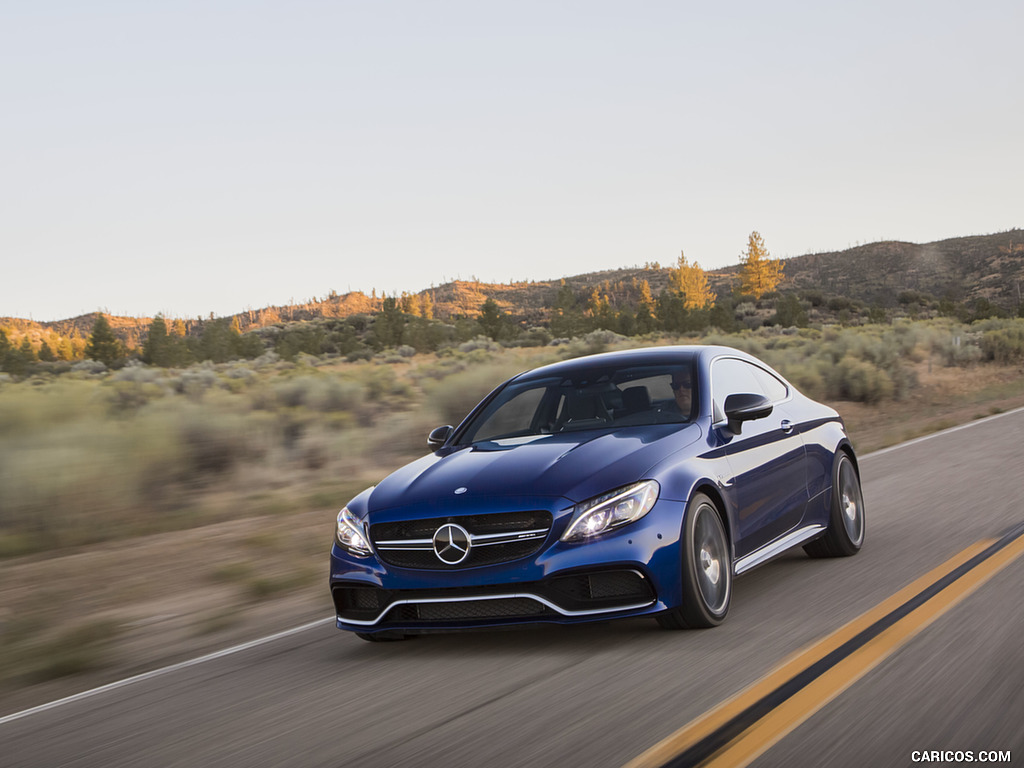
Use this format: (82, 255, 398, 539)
(656, 494, 732, 630)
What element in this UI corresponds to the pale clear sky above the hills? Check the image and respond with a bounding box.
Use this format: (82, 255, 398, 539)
(0, 0, 1024, 321)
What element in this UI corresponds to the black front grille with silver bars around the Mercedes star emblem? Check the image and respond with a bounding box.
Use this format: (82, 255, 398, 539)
(370, 510, 552, 570)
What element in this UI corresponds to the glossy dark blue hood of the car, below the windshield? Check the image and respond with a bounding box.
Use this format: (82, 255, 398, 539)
(368, 424, 700, 520)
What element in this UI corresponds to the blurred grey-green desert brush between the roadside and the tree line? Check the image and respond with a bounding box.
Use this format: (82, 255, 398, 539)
(0, 309, 1024, 557)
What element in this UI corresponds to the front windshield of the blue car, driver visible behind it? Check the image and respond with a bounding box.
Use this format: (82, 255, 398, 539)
(457, 361, 695, 445)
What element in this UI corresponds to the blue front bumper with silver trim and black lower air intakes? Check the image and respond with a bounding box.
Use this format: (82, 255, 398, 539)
(331, 502, 683, 633)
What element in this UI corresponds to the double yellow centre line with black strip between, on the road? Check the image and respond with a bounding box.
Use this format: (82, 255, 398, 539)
(626, 524, 1024, 768)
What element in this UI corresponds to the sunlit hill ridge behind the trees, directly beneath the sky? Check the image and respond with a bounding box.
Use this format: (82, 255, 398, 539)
(0, 228, 1024, 346)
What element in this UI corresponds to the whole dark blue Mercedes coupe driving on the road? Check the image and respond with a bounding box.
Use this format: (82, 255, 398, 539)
(330, 346, 864, 641)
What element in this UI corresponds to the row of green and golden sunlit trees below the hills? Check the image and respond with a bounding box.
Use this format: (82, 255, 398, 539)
(6, 231, 1024, 377)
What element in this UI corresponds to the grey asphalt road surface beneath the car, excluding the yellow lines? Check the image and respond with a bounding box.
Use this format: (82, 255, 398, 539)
(0, 412, 1024, 768)
